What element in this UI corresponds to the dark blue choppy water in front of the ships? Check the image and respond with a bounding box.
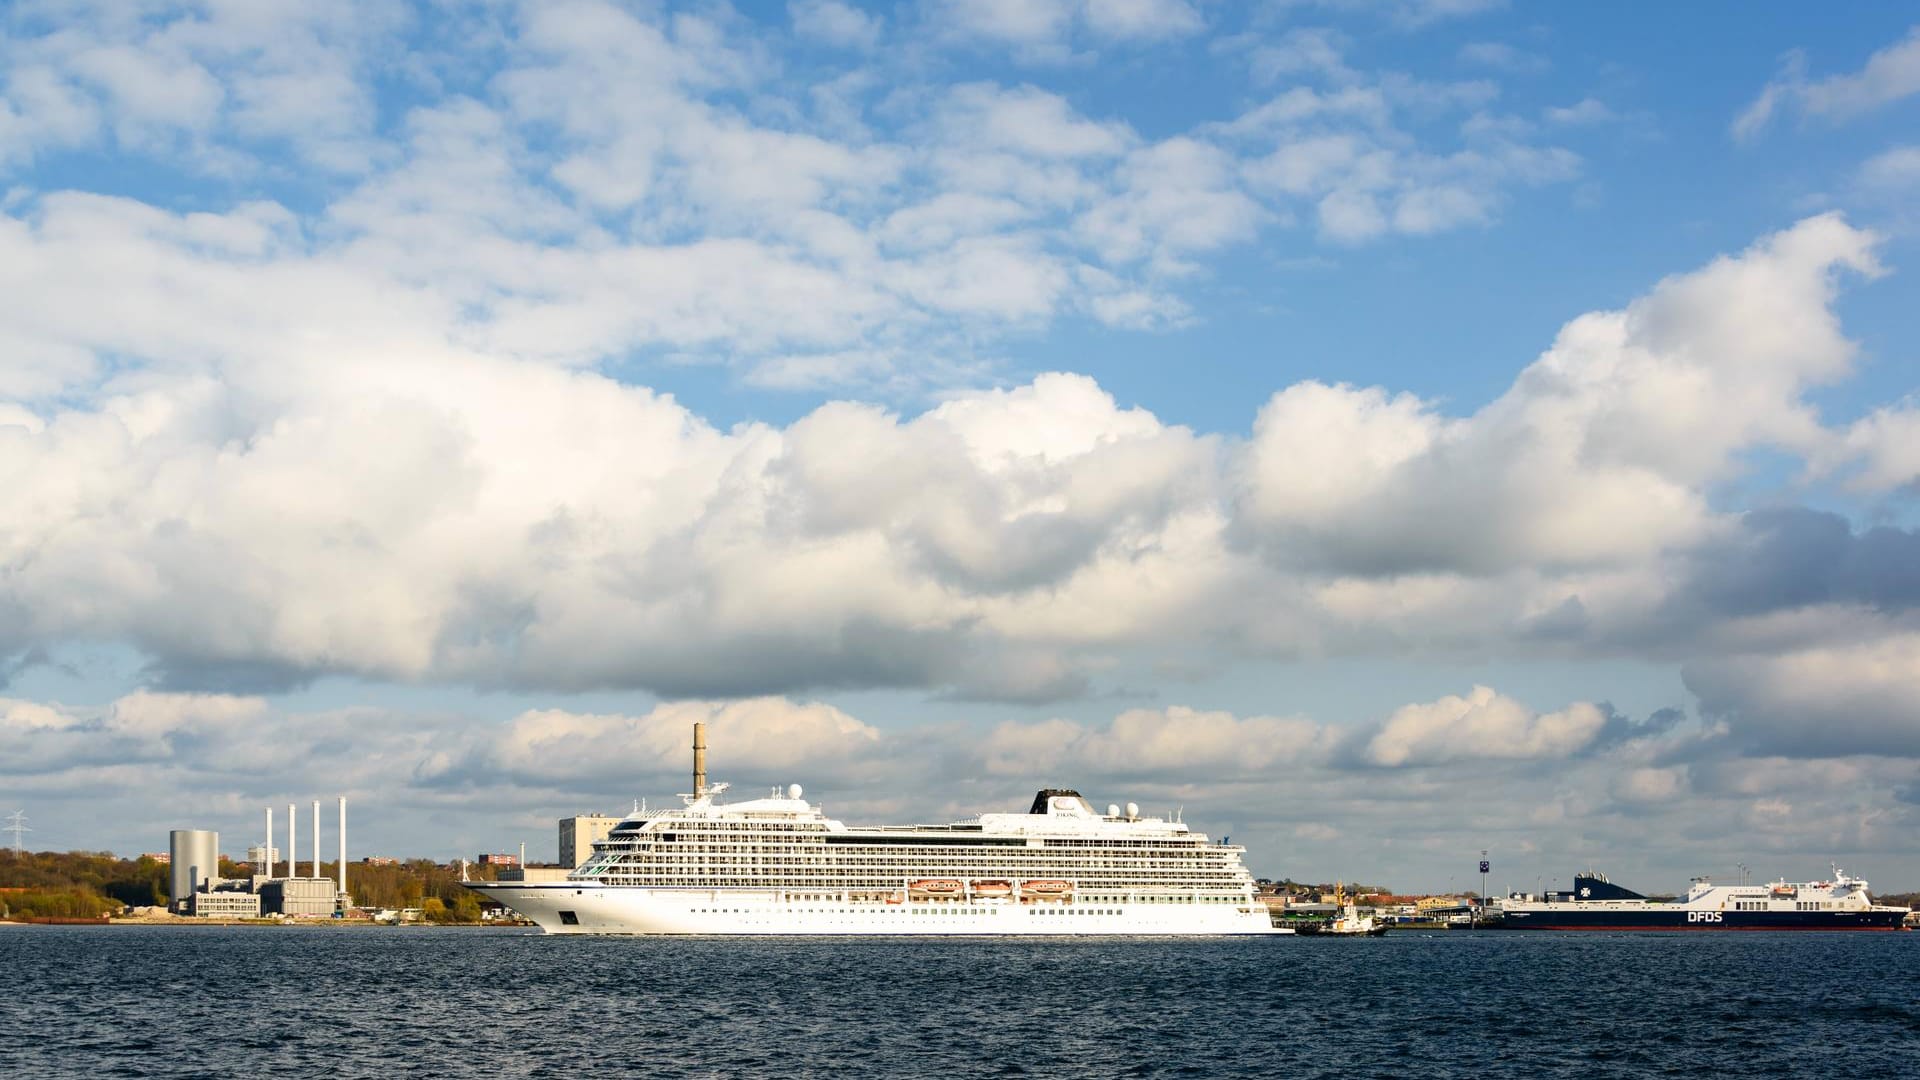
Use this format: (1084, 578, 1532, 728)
(0, 926, 1920, 1080)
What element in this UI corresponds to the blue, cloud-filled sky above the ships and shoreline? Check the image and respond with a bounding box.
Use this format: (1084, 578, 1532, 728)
(0, 0, 1920, 892)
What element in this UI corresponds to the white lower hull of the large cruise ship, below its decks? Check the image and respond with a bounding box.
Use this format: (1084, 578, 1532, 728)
(467, 882, 1275, 936)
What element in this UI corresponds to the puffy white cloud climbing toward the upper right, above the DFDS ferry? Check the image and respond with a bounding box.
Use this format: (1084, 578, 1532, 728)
(1238, 215, 1880, 575)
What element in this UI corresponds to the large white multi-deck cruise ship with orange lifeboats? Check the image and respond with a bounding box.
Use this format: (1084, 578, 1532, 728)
(467, 724, 1273, 934)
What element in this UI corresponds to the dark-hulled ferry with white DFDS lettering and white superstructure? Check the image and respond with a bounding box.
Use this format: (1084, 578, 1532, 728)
(1498, 867, 1908, 930)
